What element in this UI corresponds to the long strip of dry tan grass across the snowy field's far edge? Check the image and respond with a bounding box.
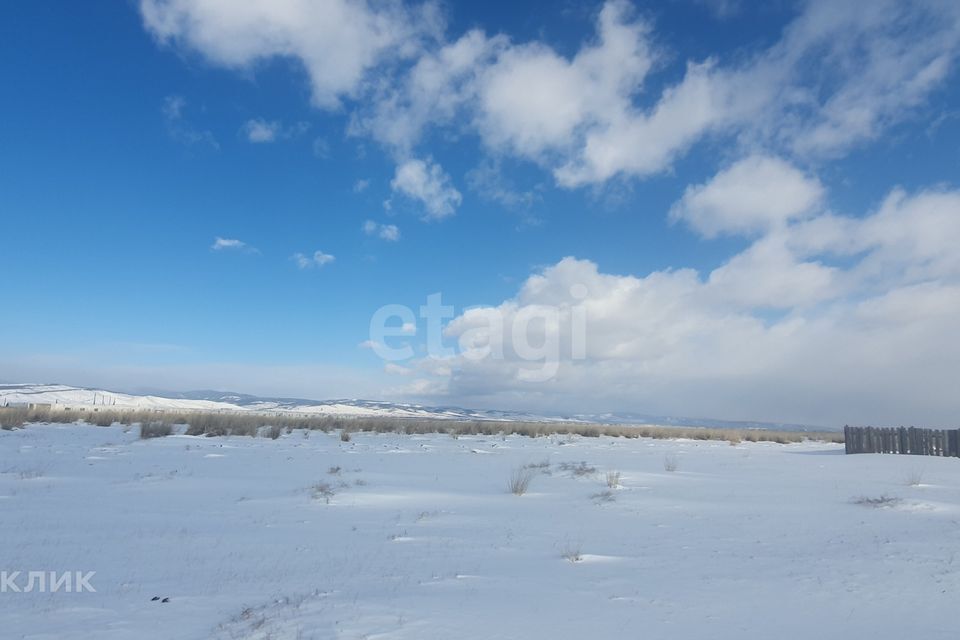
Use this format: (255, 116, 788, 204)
(0, 407, 843, 444)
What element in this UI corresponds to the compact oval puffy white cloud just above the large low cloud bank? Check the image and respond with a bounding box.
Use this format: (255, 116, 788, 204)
(670, 156, 823, 238)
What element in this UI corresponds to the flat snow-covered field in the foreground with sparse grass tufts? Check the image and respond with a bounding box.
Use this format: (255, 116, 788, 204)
(0, 425, 960, 640)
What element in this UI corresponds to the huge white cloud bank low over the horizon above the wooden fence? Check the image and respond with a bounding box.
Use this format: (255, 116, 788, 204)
(388, 182, 960, 425)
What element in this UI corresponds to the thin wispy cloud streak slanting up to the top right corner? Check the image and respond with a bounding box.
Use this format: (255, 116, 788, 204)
(555, 0, 960, 187)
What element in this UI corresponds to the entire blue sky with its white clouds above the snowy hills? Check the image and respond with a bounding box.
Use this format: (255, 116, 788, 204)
(0, 0, 960, 424)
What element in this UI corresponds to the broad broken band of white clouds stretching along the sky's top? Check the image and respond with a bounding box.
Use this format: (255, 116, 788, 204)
(140, 0, 960, 195)
